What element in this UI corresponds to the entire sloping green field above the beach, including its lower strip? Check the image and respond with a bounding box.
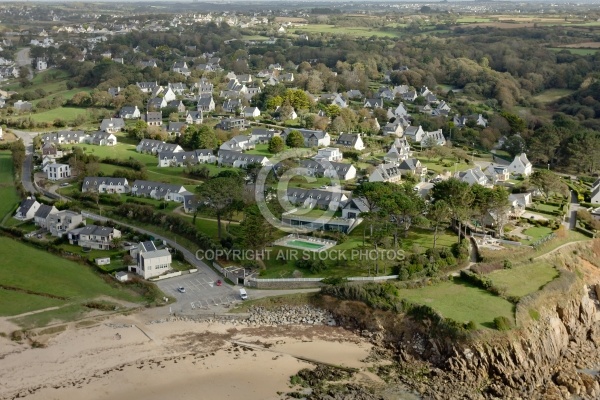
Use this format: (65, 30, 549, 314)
(0, 237, 140, 324)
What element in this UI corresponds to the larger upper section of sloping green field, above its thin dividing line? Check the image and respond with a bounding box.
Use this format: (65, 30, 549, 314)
(0, 237, 139, 304)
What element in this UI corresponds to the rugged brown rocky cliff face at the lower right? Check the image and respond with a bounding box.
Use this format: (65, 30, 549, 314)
(410, 244, 600, 399)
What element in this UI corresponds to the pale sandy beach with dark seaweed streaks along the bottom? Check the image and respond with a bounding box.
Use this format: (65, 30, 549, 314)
(0, 315, 377, 400)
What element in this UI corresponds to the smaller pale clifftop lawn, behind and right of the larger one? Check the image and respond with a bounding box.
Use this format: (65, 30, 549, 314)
(488, 261, 559, 297)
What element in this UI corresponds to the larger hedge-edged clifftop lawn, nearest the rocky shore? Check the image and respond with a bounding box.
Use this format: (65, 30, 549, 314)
(400, 279, 514, 328)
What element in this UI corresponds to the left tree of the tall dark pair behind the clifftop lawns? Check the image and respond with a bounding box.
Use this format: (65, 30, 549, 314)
(431, 178, 474, 243)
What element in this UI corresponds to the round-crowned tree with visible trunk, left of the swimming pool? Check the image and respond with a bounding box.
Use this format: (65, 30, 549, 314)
(196, 175, 244, 239)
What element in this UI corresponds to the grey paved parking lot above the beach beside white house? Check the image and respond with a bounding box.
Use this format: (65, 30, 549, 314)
(156, 271, 241, 314)
